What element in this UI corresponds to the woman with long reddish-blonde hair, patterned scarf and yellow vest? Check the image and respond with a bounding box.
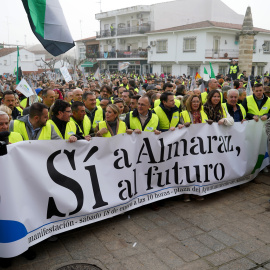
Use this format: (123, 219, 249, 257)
(180, 95, 208, 124)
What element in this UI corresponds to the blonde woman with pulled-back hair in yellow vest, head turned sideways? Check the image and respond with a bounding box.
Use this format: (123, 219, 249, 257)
(96, 104, 127, 137)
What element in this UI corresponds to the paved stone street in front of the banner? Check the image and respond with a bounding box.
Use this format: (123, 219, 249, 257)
(6, 173, 270, 270)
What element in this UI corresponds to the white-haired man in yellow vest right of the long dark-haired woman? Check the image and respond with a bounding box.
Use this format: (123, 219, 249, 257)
(222, 89, 247, 123)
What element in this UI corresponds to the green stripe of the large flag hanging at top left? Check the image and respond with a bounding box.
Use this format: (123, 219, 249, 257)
(28, 0, 46, 38)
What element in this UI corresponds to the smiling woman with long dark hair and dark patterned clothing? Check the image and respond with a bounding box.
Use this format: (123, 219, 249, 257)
(203, 90, 234, 126)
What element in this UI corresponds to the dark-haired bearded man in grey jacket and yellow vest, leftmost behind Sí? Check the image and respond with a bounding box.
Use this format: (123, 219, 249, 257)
(9, 103, 60, 140)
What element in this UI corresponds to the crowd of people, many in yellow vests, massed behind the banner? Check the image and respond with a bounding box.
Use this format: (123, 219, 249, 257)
(0, 69, 270, 266)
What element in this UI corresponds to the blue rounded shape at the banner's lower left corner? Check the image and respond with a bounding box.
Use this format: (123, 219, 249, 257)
(0, 220, 27, 243)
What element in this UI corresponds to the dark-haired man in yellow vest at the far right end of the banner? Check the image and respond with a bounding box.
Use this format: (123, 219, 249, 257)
(242, 83, 270, 122)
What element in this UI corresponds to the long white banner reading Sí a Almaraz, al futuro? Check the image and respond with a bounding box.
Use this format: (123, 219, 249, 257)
(0, 121, 269, 258)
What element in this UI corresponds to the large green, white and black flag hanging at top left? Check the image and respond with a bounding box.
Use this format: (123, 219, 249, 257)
(22, 0, 75, 56)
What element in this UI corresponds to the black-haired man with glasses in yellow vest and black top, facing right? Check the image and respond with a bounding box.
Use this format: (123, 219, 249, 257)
(48, 99, 84, 142)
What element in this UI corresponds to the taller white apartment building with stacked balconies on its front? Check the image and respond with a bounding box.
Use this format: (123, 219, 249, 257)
(95, 0, 244, 73)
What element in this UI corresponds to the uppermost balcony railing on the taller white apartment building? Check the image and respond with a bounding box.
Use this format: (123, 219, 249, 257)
(96, 23, 151, 38)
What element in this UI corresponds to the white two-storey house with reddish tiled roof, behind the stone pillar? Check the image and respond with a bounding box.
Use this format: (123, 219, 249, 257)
(148, 21, 270, 76)
